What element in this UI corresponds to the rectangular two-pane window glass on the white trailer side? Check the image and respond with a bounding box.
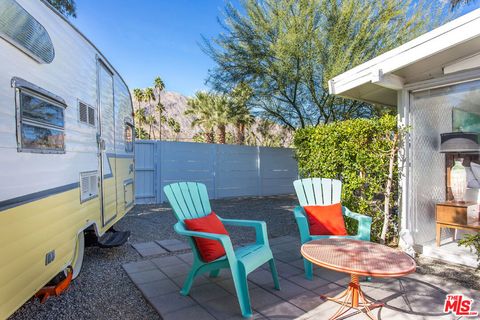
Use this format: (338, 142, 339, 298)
(18, 89, 65, 153)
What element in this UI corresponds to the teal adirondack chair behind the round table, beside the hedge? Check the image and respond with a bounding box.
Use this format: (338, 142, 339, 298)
(293, 178, 372, 280)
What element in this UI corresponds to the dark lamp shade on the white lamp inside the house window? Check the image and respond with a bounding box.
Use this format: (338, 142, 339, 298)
(440, 132, 480, 153)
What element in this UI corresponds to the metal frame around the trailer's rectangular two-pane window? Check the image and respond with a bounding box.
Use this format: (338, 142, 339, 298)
(12, 78, 67, 154)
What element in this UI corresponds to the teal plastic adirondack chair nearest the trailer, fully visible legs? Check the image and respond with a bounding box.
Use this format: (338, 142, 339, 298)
(163, 182, 280, 318)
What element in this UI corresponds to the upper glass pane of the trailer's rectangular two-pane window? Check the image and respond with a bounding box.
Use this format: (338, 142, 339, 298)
(20, 93, 64, 127)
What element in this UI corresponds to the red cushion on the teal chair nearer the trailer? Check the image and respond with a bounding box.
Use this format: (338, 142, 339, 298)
(183, 211, 228, 262)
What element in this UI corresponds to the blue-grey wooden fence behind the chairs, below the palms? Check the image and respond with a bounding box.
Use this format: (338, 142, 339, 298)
(135, 140, 298, 204)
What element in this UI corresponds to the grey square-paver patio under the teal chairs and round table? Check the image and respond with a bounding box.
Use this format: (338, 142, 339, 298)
(124, 236, 464, 320)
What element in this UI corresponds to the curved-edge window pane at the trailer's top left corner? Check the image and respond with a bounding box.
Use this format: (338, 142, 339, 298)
(0, 0, 55, 63)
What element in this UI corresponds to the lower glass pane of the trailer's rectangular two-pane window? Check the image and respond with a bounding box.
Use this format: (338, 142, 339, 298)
(22, 123, 63, 150)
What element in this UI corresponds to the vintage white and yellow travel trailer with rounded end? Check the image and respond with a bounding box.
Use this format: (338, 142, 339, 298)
(0, 0, 134, 319)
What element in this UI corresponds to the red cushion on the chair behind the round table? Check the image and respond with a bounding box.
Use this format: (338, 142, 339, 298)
(303, 203, 347, 236)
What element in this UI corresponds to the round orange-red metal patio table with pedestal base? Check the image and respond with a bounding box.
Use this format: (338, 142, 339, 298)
(301, 238, 416, 319)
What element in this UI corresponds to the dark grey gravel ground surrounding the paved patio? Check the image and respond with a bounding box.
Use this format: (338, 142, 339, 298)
(10, 196, 480, 320)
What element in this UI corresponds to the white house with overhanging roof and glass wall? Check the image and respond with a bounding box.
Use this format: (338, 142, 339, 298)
(329, 9, 480, 266)
